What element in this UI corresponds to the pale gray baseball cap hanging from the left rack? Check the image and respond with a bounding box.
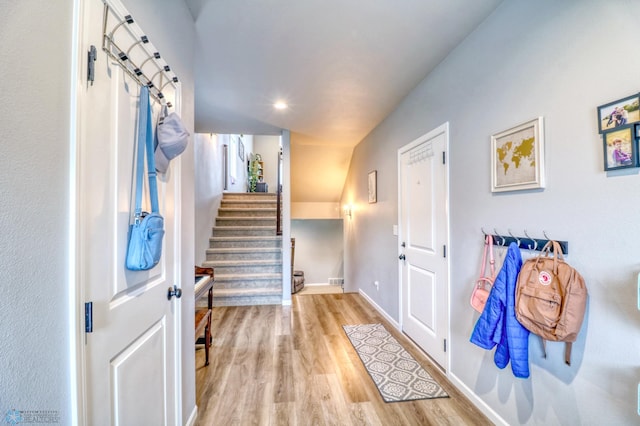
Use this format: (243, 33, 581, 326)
(155, 106, 189, 173)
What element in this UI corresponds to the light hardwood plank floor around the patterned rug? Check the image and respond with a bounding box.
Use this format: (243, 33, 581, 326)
(196, 293, 491, 426)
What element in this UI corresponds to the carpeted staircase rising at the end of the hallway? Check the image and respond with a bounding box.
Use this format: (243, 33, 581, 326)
(202, 192, 282, 306)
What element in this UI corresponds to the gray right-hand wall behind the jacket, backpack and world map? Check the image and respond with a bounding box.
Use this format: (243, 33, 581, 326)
(343, 0, 640, 425)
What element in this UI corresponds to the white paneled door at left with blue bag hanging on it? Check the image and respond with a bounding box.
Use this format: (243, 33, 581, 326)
(77, 0, 181, 425)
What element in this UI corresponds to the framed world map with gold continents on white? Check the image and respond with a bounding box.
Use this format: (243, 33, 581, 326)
(491, 117, 544, 192)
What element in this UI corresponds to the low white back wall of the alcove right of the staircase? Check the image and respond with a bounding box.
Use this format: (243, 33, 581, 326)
(291, 219, 344, 284)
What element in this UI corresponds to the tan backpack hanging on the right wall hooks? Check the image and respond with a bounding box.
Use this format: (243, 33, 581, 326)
(516, 241, 587, 365)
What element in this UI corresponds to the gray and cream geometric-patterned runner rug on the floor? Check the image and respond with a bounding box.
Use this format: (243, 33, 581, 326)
(342, 324, 449, 402)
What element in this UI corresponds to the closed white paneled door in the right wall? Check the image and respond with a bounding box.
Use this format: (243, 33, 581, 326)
(398, 124, 449, 370)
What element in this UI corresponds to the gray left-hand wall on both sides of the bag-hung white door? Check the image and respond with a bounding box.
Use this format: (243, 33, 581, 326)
(0, 0, 195, 424)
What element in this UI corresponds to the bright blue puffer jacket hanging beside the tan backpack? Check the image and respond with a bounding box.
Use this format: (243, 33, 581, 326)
(471, 243, 529, 378)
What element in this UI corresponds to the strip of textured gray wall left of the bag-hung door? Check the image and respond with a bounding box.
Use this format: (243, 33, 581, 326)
(0, 0, 73, 424)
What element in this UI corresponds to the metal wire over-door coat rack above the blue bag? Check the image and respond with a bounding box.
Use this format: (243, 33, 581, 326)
(102, 2, 179, 107)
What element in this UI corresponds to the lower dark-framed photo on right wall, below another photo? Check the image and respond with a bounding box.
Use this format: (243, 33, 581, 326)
(602, 124, 638, 170)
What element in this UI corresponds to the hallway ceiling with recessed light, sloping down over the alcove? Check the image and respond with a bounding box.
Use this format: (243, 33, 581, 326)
(185, 0, 502, 202)
